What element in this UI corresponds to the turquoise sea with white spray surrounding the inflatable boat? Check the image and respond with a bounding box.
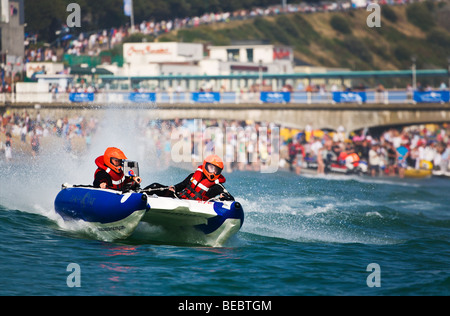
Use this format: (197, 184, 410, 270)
(0, 155, 450, 296)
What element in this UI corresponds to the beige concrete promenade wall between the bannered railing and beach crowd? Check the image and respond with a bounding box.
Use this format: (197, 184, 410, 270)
(0, 102, 450, 131)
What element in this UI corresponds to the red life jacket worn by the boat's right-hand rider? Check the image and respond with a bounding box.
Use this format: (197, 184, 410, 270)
(180, 165, 226, 201)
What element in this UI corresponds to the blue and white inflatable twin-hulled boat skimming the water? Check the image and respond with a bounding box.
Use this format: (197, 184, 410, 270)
(55, 184, 244, 247)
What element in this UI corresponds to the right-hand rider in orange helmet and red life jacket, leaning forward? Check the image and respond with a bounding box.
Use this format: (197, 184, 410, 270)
(169, 155, 234, 201)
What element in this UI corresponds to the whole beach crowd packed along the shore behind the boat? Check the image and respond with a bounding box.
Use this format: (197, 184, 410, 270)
(0, 110, 450, 177)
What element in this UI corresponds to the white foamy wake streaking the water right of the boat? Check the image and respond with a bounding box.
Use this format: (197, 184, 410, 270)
(236, 188, 408, 245)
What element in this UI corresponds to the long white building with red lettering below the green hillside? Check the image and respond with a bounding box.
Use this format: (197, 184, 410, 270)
(123, 42, 294, 76)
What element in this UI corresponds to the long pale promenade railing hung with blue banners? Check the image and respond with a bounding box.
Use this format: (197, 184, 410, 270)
(0, 90, 448, 104)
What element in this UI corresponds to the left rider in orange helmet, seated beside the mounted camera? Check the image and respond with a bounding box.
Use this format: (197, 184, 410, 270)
(93, 147, 141, 191)
